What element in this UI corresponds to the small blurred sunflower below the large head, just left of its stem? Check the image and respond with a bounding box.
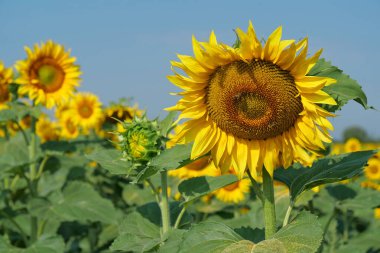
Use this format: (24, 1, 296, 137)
(215, 170, 250, 204)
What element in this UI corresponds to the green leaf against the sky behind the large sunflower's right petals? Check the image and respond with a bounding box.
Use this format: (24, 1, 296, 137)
(308, 59, 372, 112)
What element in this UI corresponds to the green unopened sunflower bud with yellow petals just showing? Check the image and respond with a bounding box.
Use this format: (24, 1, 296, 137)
(119, 116, 165, 165)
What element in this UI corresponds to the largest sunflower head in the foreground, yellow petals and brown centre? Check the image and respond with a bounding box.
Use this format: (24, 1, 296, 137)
(168, 23, 336, 177)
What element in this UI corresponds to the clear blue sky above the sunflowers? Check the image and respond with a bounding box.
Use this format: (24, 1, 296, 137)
(0, 0, 380, 139)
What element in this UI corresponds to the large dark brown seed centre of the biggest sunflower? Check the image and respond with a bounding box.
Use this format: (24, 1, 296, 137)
(206, 60, 303, 140)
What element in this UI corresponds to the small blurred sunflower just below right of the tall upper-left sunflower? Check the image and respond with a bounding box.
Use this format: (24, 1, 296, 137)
(65, 93, 104, 131)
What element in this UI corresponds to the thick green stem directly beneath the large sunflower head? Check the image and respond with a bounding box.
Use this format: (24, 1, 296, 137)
(263, 167, 276, 239)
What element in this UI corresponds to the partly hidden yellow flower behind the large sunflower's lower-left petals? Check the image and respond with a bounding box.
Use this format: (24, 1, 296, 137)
(169, 156, 219, 178)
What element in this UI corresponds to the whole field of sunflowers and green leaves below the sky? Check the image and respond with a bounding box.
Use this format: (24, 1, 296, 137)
(0, 22, 380, 253)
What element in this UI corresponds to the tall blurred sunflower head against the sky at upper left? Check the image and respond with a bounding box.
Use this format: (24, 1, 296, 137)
(16, 40, 81, 108)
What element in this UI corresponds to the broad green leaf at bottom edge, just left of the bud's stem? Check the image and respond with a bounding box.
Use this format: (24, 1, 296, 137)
(110, 212, 161, 252)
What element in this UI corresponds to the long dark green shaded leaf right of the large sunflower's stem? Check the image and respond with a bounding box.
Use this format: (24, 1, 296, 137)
(274, 150, 376, 201)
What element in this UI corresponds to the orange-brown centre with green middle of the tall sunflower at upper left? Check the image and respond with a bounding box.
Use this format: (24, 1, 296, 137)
(30, 58, 65, 92)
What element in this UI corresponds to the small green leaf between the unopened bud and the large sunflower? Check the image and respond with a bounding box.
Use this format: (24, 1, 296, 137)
(150, 143, 193, 171)
